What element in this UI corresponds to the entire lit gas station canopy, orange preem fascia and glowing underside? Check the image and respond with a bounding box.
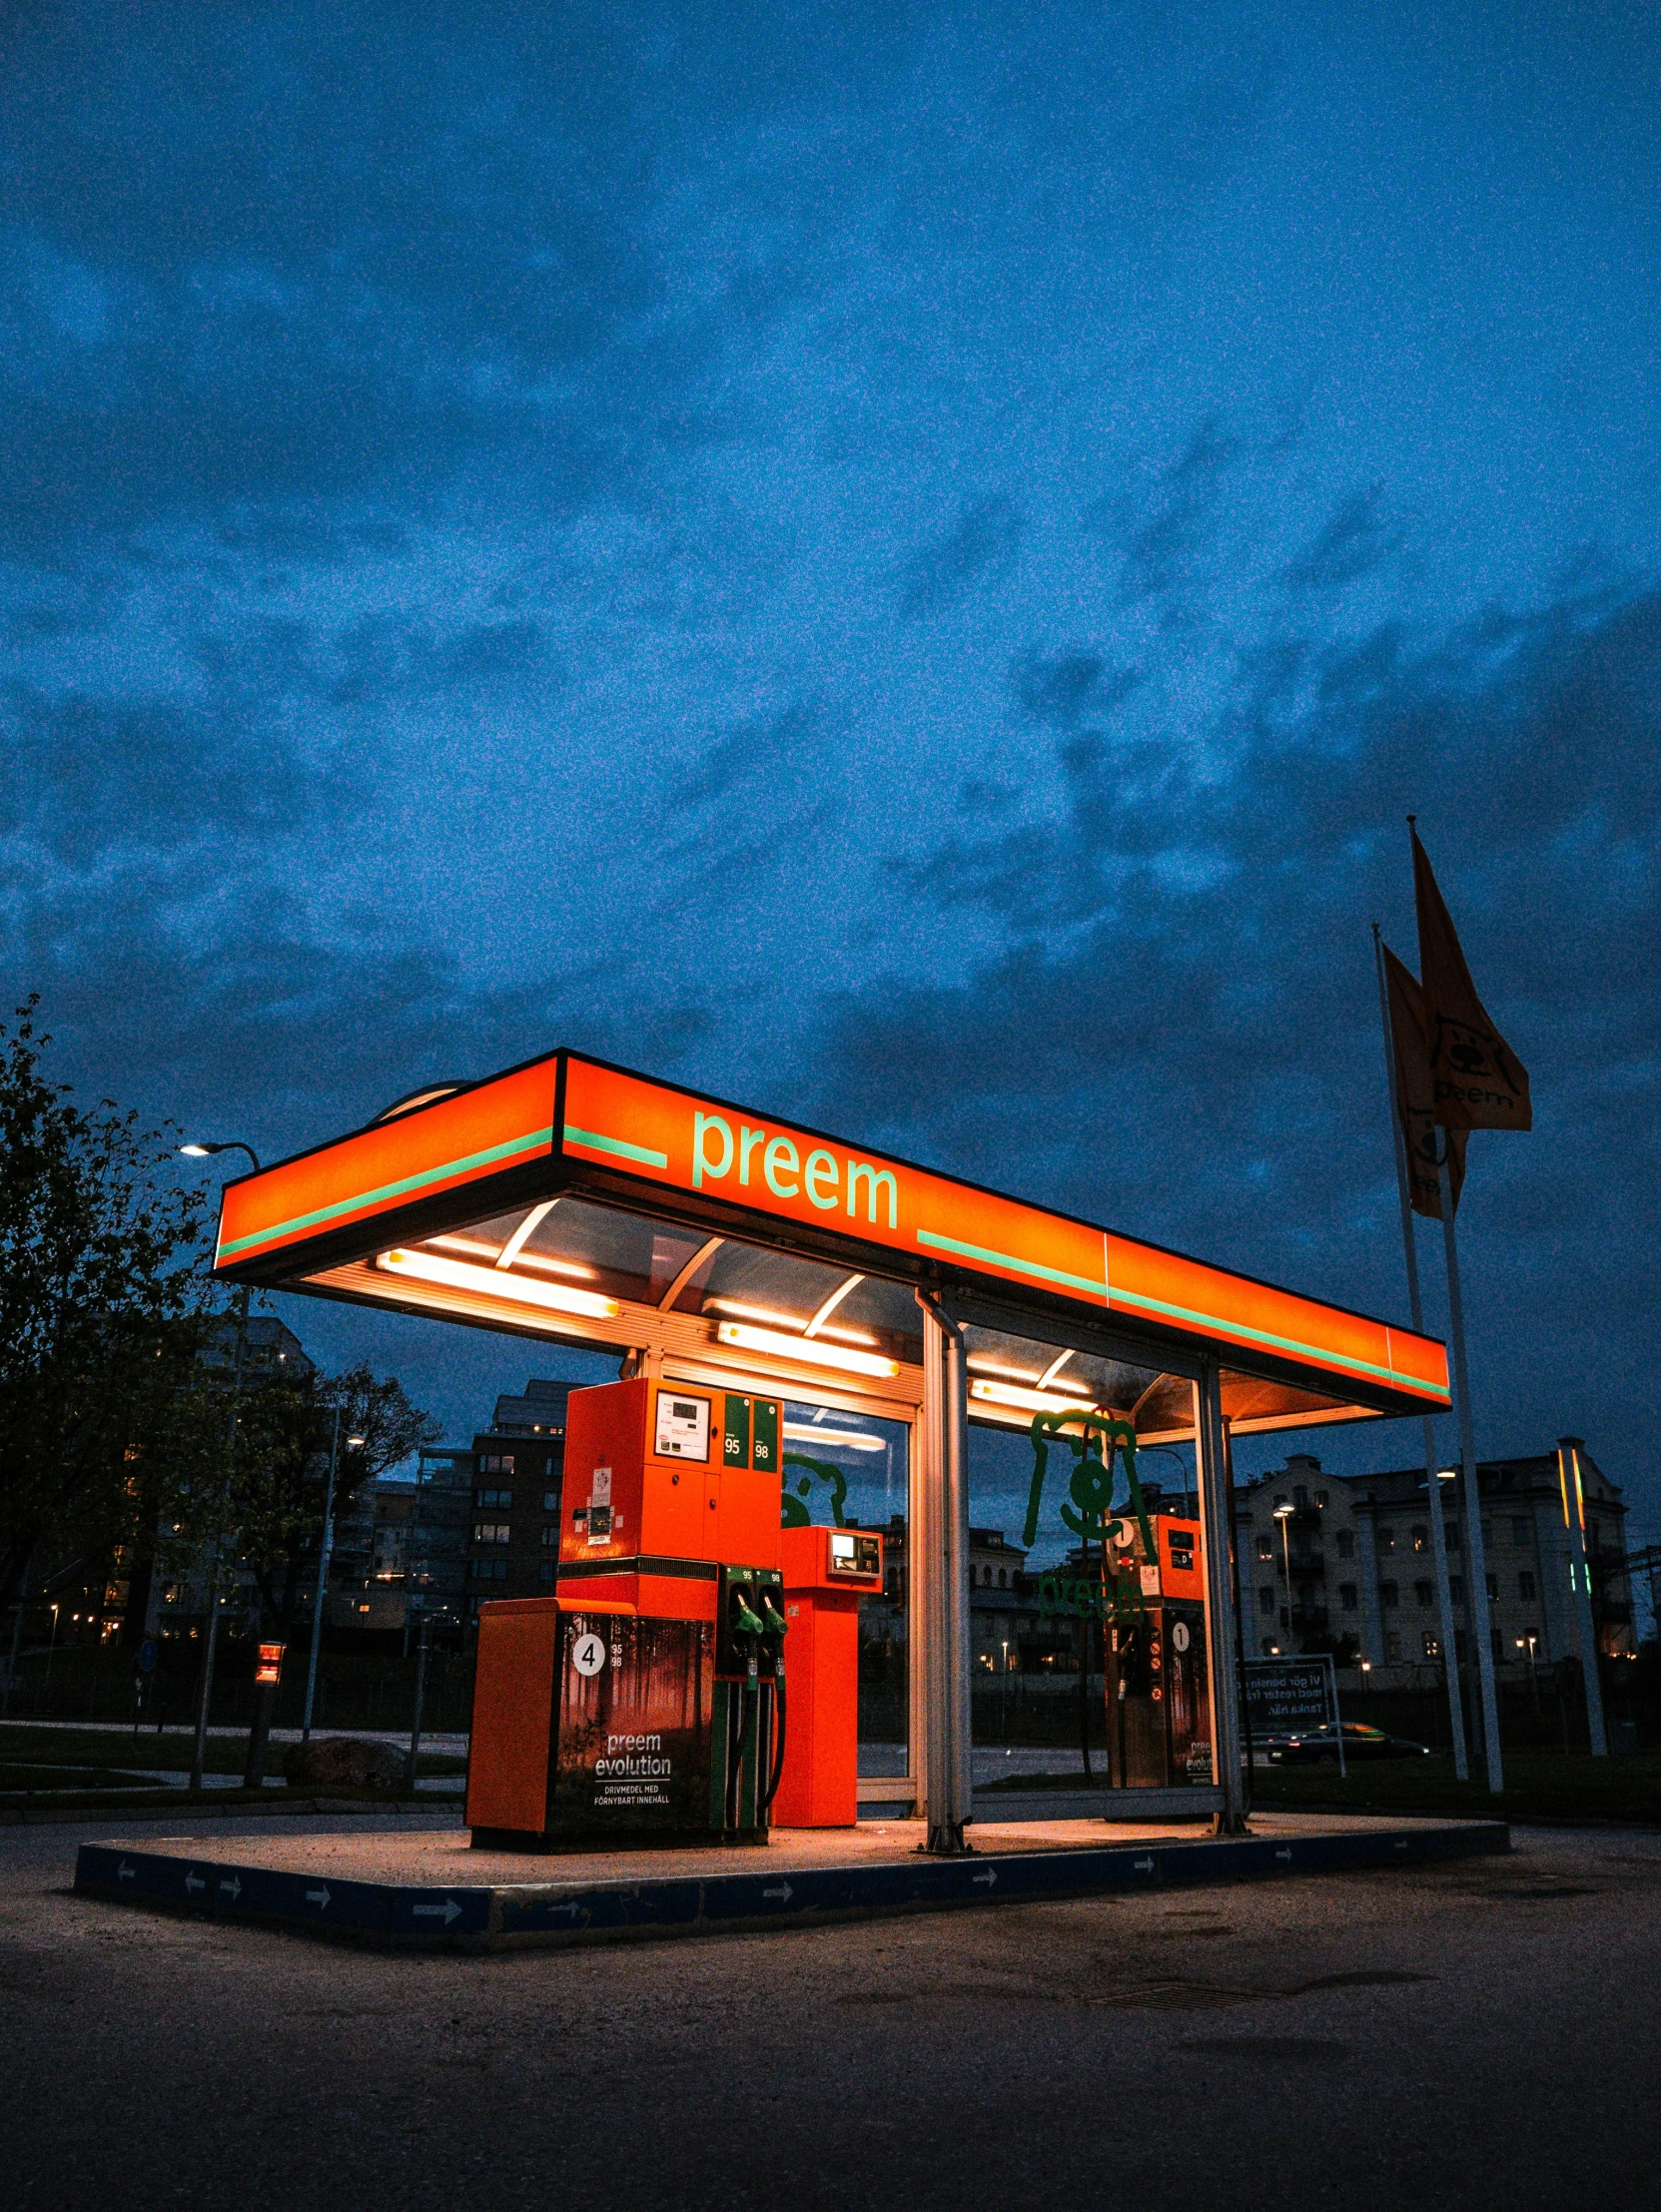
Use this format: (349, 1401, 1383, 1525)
(215, 1051, 1448, 1442)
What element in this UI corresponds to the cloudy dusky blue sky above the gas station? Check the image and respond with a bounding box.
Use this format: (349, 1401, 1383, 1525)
(0, 0, 1661, 1517)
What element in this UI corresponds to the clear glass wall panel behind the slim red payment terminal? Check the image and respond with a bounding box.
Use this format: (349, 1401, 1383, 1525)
(783, 1398, 911, 1774)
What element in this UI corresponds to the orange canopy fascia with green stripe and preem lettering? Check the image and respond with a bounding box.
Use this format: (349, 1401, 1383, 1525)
(215, 1051, 1448, 1413)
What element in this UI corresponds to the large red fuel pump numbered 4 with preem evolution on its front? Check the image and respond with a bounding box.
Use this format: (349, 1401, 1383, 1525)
(466, 1376, 785, 1847)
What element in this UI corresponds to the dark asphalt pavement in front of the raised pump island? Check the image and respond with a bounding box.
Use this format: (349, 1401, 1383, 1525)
(0, 1817, 1661, 2212)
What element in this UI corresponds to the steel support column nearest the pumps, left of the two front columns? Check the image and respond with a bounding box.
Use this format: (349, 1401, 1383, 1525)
(911, 1296, 971, 1855)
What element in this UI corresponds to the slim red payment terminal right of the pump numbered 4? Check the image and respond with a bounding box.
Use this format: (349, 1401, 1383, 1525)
(772, 1529, 883, 1828)
